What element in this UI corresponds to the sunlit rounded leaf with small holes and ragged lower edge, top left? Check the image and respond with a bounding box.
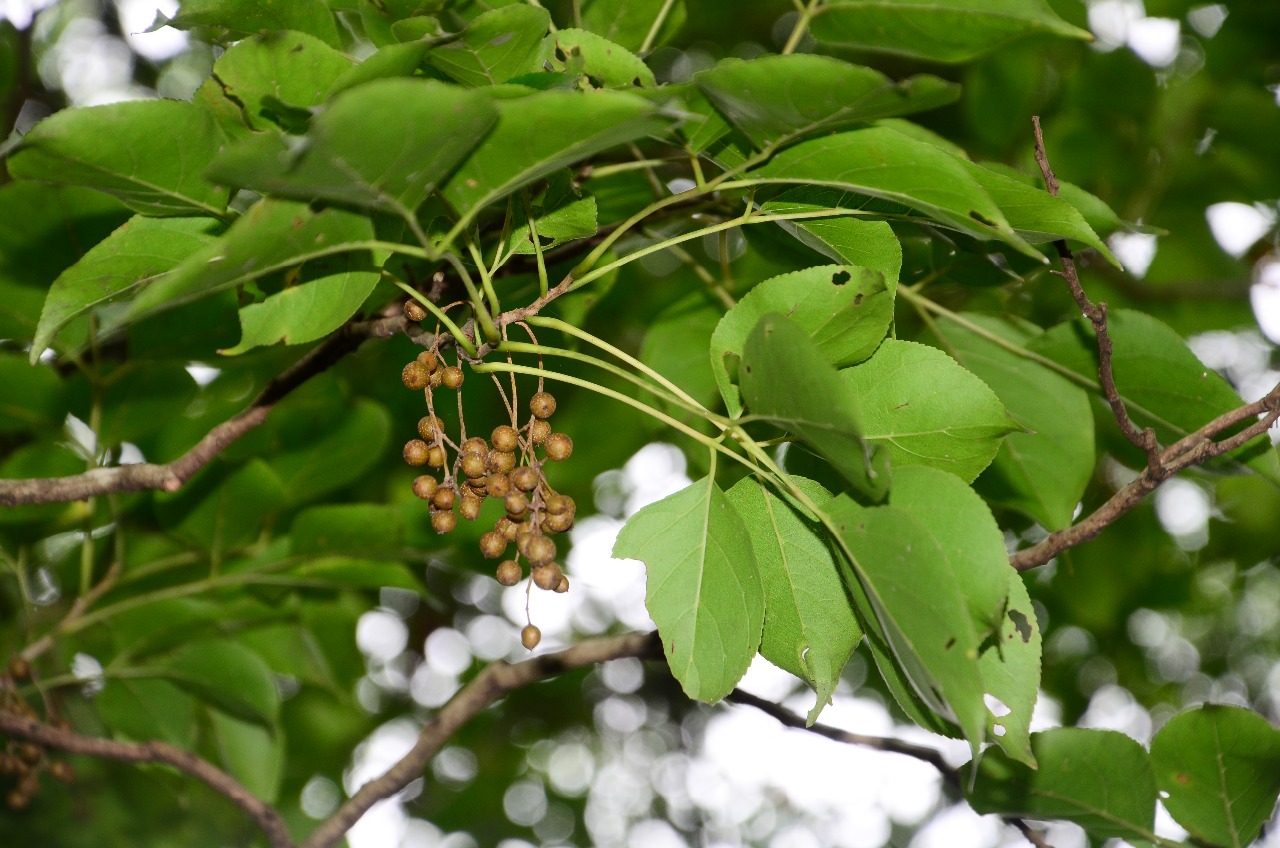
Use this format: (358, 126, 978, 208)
(195, 32, 355, 132)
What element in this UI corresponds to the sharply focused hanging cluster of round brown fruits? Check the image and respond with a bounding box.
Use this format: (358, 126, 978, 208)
(401, 325, 577, 649)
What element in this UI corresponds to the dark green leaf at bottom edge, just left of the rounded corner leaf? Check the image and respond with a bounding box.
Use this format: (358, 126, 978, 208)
(969, 728, 1157, 842)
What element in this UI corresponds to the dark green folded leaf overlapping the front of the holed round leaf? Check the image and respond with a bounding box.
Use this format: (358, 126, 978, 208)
(740, 313, 890, 501)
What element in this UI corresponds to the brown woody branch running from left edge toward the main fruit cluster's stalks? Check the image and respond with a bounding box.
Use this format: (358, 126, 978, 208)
(0, 315, 417, 506)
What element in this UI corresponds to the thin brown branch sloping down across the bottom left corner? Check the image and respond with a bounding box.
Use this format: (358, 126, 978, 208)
(0, 711, 293, 848)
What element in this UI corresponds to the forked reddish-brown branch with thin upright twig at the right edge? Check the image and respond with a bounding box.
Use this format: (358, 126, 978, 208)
(1009, 117, 1280, 571)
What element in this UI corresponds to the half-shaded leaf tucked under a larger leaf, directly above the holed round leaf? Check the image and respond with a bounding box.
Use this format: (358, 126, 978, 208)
(760, 186, 902, 281)
